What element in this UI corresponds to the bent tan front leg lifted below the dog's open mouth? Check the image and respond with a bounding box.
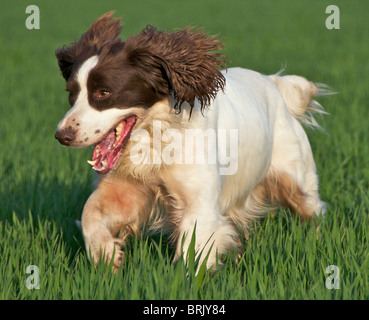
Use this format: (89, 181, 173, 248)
(82, 179, 148, 269)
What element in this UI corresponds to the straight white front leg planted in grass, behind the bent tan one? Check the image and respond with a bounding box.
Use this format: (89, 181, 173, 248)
(167, 166, 238, 269)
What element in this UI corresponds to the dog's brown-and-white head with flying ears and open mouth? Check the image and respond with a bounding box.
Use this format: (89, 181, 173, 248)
(55, 12, 225, 173)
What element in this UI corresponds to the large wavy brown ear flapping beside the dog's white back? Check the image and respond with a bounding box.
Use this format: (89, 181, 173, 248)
(124, 26, 225, 111)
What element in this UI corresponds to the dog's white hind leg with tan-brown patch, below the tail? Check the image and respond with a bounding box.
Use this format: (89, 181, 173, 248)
(262, 119, 325, 220)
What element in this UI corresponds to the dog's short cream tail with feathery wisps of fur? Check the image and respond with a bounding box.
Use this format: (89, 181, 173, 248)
(270, 73, 333, 128)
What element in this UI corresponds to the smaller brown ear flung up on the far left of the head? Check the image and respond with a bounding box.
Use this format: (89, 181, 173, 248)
(55, 11, 122, 80)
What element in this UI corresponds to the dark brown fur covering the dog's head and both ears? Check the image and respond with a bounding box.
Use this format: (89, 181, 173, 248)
(55, 12, 225, 111)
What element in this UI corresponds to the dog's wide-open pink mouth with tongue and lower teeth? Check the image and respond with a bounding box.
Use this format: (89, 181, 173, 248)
(87, 116, 137, 174)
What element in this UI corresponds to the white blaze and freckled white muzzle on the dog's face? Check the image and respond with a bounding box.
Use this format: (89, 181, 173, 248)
(58, 55, 136, 147)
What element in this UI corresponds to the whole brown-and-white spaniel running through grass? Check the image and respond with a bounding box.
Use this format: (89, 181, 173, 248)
(55, 12, 325, 269)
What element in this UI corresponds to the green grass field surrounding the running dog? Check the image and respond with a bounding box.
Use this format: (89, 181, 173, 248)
(0, 0, 369, 300)
